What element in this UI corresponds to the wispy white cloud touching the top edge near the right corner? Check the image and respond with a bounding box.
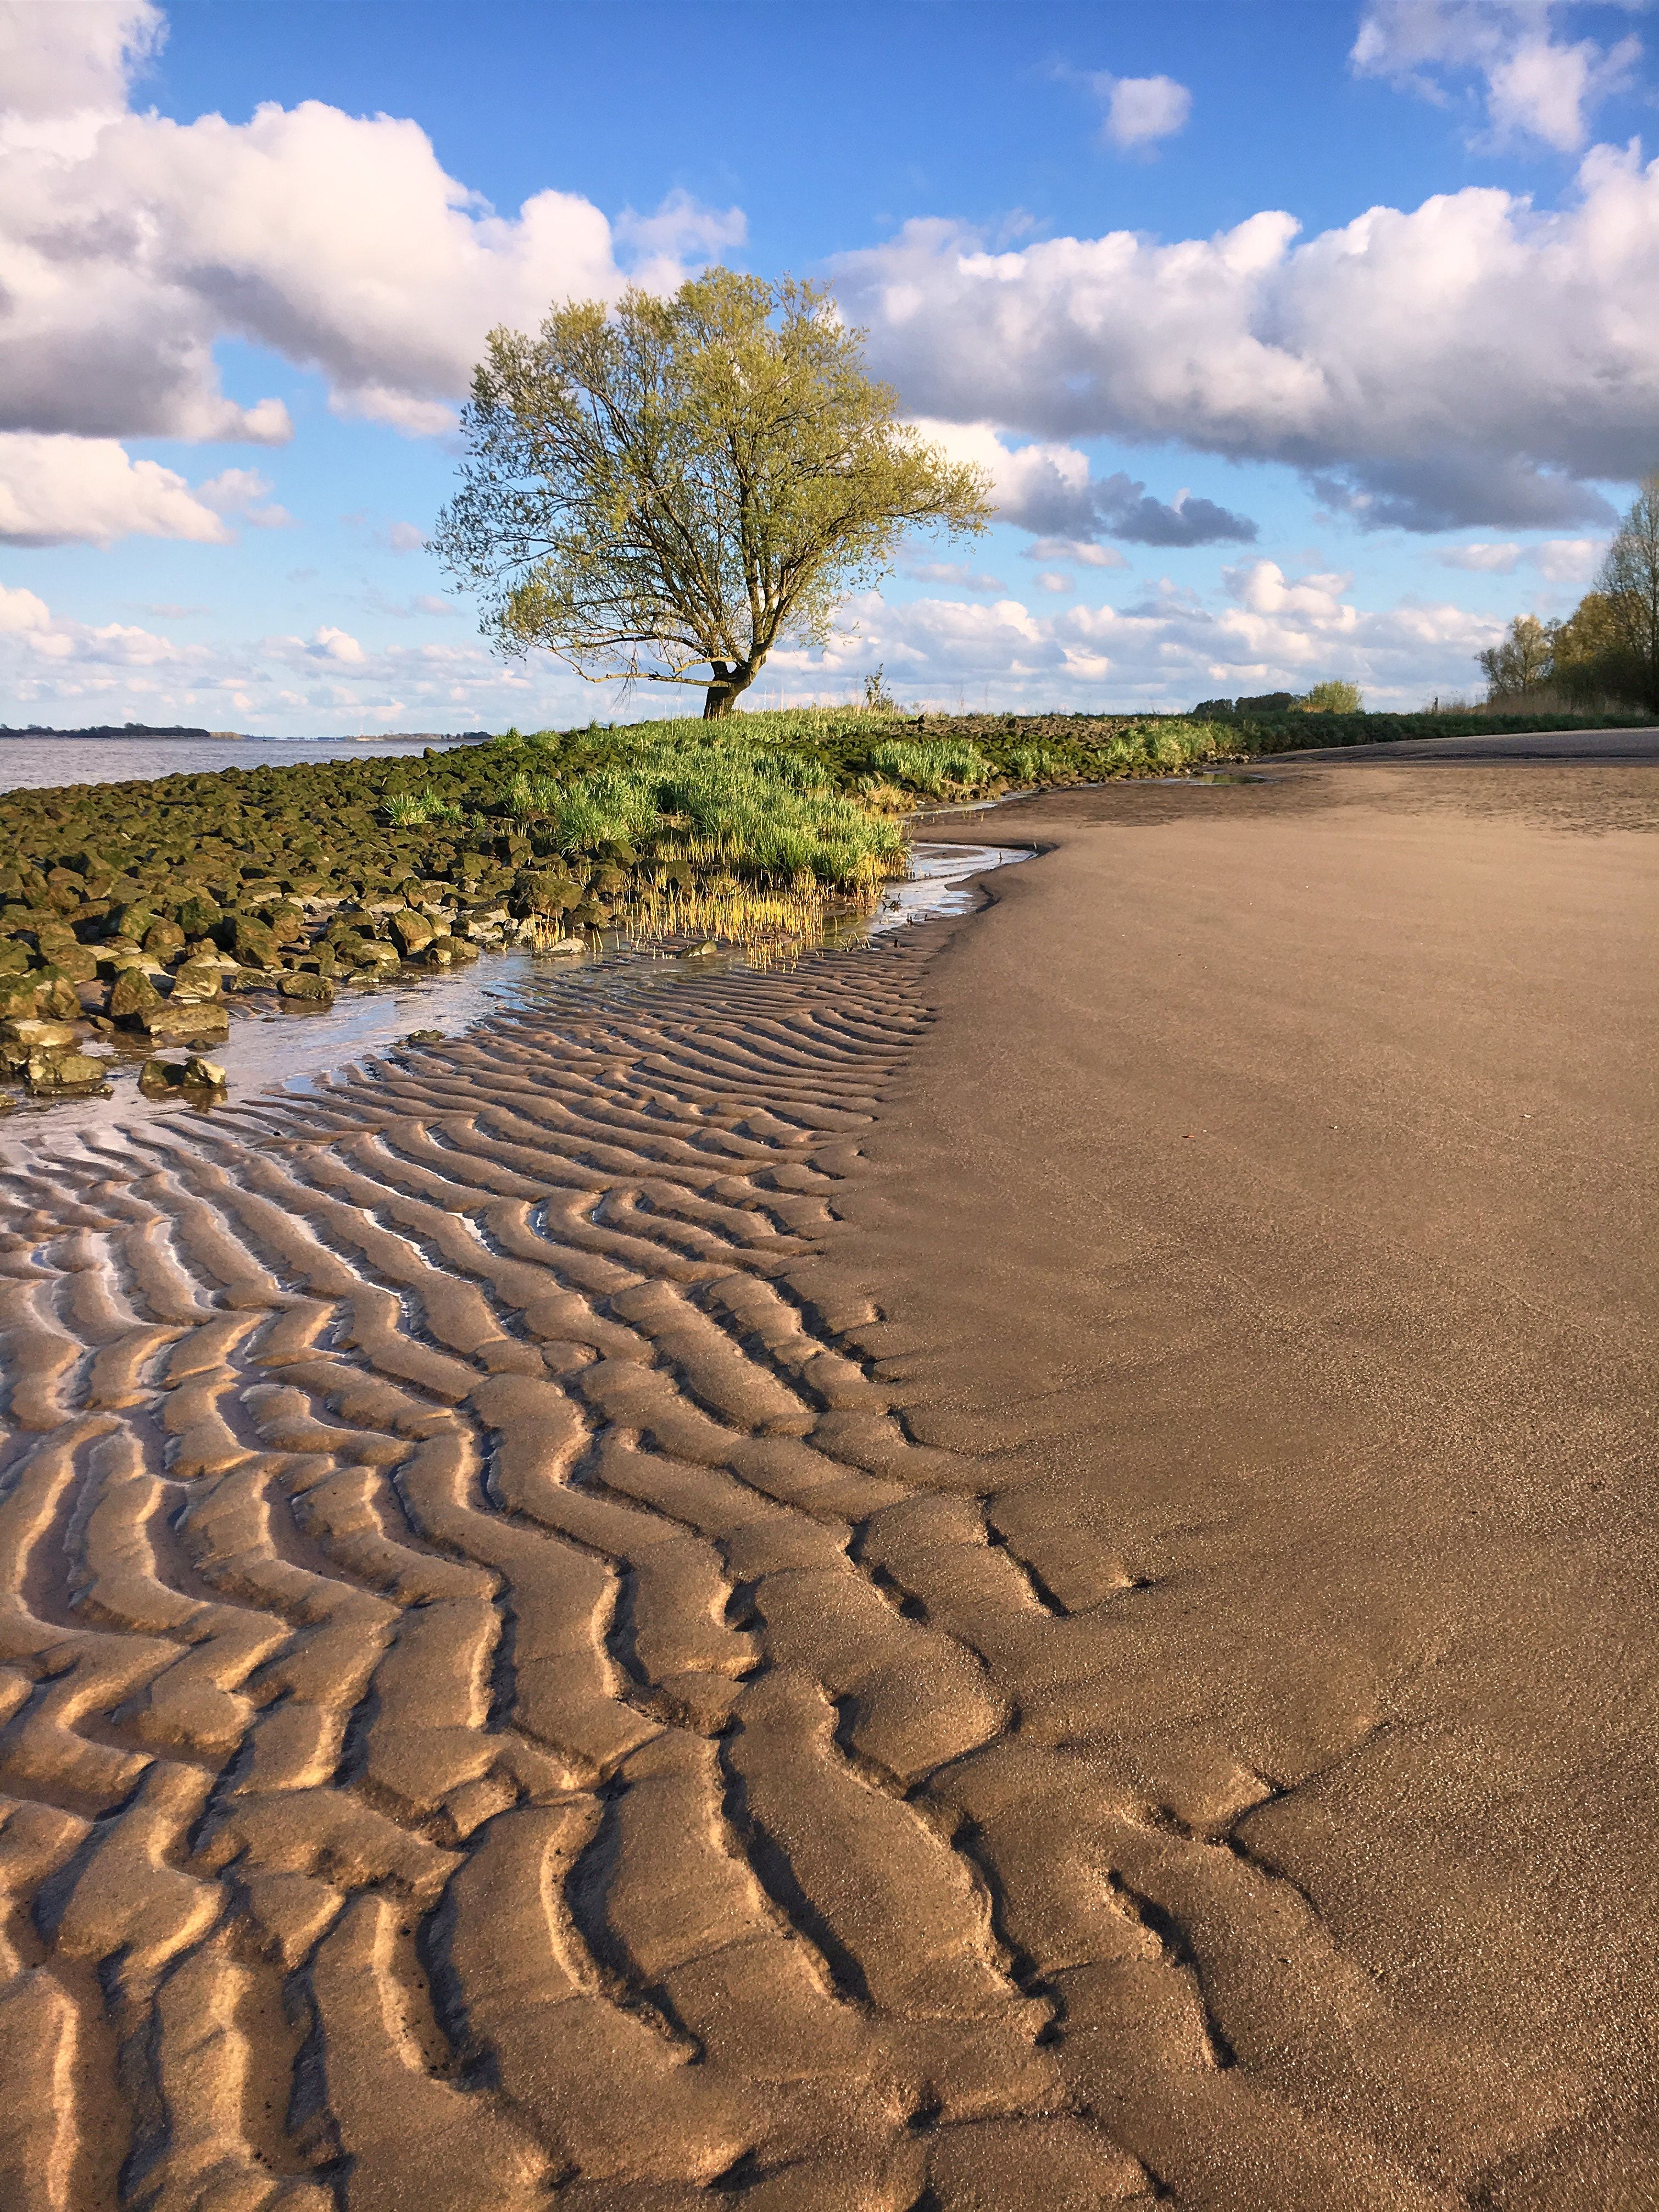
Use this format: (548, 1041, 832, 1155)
(1351, 0, 1641, 153)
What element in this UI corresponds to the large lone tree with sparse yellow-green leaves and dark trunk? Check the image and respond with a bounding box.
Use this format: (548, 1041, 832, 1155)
(433, 270, 991, 716)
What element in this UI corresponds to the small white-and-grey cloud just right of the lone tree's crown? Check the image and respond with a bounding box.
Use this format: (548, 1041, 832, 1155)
(918, 418, 1256, 546)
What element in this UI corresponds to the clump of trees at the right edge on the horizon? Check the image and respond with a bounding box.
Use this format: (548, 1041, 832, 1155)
(1476, 469, 1659, 712)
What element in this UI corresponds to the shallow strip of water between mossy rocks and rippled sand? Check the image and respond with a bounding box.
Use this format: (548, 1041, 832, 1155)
(0, 843, 1031, 1151)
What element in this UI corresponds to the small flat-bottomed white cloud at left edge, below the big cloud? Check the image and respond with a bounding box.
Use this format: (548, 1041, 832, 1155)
(0, 433, 234, 546)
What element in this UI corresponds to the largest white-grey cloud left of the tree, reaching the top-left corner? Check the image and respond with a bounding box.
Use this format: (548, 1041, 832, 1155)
(0, 0, 741, 460)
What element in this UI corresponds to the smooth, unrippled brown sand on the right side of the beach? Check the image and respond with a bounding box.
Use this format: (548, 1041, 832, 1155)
(822, 763, 1659, 2212)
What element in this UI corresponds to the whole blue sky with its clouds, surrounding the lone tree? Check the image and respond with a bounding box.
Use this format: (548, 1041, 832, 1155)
(0, 0, 1659, 737)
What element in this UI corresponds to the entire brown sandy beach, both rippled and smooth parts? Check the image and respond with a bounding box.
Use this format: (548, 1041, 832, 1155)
(0, 763, 1659, 2212)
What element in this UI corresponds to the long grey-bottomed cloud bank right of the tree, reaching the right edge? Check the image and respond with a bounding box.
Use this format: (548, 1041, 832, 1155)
(838, 146, 1659, 542)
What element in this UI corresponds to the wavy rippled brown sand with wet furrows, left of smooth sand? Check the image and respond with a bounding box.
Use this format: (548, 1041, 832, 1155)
(0, 951, 1159, 2212)
